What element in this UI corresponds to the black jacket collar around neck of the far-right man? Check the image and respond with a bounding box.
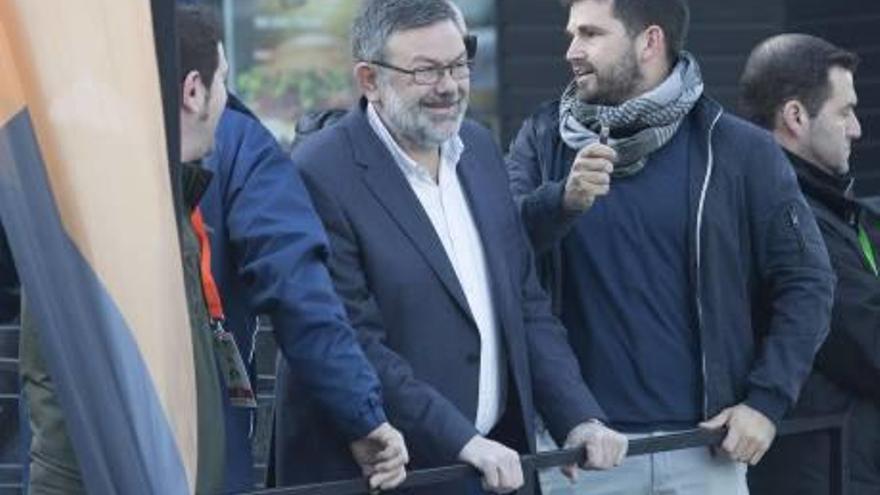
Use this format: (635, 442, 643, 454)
(785, 150, 861, 224)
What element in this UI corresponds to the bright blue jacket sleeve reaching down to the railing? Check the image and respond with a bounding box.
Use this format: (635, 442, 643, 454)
(224, 118, 386, 440)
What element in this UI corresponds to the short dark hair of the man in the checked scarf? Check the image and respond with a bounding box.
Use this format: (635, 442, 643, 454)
(562, 0, 691, 64)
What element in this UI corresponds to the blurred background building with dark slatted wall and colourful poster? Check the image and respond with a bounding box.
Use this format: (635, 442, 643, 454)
(201, 0, 880, 194)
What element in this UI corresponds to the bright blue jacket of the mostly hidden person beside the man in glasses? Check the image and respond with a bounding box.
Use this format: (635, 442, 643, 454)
(200, 98, 385, 491)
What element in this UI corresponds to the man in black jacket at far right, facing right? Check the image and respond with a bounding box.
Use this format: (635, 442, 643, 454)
(741, 34, 880, 495)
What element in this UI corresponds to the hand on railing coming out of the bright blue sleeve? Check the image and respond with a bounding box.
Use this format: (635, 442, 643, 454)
(351, 423, 409, 490)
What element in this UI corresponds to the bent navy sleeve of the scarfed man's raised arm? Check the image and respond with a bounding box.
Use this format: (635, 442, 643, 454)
(505, 113, 578, 256)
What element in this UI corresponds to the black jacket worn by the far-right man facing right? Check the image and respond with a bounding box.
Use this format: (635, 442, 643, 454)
(749, 154, 880, 495)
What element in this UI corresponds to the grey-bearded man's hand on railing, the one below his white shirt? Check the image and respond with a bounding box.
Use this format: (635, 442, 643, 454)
(458, 435, 523, 493)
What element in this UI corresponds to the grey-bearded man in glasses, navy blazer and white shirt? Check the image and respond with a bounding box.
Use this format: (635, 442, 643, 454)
(276, 0, 626, 495)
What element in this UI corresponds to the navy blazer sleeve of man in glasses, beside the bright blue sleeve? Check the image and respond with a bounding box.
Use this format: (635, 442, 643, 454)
(303, 162, 479, 463)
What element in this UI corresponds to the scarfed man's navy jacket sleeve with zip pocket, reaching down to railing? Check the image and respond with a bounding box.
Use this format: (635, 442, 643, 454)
(744, 135, 834, 423)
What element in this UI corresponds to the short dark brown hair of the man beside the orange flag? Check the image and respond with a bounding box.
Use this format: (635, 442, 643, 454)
(176, 5, 223, 89)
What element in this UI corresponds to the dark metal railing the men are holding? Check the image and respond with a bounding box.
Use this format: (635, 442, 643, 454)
(250, 414, 847, 495)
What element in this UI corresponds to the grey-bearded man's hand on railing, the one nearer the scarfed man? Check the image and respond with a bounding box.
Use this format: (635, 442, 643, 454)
(562, 421, 629, 482)
